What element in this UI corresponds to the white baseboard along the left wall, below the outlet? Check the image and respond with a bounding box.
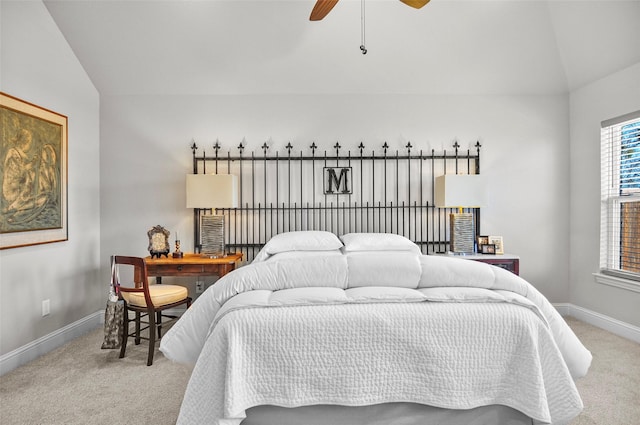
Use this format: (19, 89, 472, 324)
(0, 310, 104, 376)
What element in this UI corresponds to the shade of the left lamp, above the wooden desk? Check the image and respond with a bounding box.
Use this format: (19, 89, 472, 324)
(187, 174, 238, 208)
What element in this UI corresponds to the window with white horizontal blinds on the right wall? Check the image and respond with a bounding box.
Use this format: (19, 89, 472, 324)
(600, 111, 640, 285)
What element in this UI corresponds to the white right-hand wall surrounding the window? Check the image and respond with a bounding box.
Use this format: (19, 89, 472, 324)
(570, 64, 640, 326)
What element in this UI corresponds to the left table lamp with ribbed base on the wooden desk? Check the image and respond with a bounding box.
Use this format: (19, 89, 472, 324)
(187, 174, 238, 258)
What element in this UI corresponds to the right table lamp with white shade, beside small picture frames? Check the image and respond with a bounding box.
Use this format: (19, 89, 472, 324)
(435, 174, 486, 254)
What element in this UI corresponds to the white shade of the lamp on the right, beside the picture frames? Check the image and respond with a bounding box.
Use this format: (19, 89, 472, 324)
(435, 174, 487, 208)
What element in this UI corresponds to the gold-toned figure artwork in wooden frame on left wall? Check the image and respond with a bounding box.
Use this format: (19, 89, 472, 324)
(0, 92, 69, 249)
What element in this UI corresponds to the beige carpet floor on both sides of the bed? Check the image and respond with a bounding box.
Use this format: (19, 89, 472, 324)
(0, 318, 640, 425)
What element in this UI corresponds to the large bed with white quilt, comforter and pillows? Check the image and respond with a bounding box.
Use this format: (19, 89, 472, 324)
(160, 231, 591, 425)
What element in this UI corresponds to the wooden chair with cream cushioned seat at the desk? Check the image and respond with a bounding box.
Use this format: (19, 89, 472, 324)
(112, 255, 191, 366)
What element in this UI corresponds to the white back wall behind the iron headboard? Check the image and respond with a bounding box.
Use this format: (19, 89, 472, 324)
(100, 95, 569, 302)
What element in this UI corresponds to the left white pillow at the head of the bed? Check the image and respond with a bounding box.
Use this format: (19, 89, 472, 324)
(263, 230, 342, 255)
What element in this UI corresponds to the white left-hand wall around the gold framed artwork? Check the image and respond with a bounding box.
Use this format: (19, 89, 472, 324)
(0, 0, 101, 355)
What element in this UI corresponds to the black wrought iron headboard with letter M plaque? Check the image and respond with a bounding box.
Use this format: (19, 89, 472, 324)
(191, 141, 481, 262)
